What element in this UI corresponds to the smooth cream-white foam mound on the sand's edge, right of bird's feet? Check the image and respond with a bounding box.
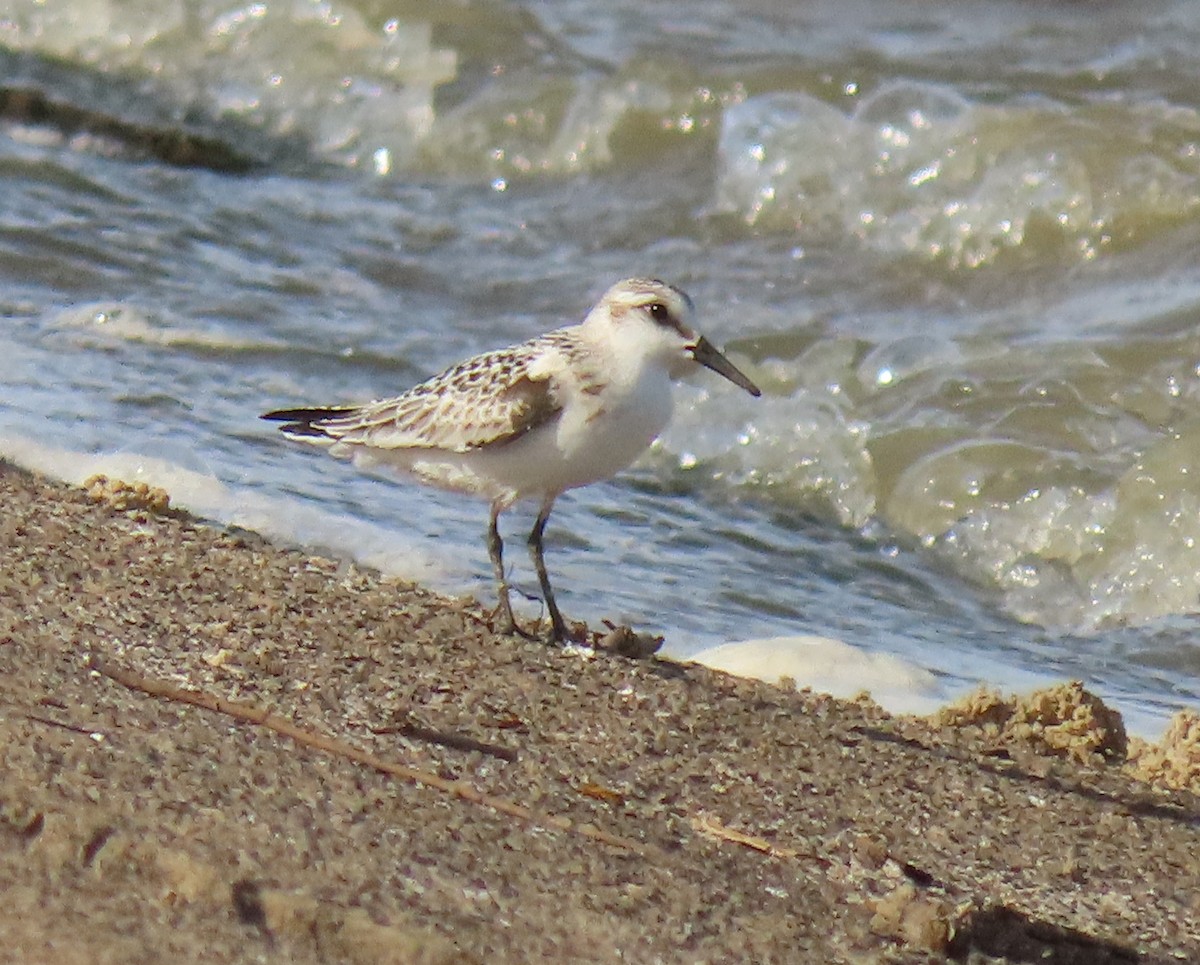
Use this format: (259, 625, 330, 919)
(691, 635, 948, 714)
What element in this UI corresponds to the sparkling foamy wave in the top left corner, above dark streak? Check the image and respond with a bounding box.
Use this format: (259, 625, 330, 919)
(0, 0, 456, 174)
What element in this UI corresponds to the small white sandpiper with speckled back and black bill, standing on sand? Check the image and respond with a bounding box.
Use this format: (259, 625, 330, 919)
(262, 278, 761, 641)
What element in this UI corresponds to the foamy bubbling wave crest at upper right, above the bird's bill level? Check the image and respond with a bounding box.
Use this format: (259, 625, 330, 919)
(715, 82, 1200, 268)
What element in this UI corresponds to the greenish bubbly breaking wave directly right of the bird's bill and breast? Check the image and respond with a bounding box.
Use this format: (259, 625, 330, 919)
(658, 314, 1200, 634)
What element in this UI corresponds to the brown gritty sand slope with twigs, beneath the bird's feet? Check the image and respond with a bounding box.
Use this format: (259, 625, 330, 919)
(0, 464, 1200, 963)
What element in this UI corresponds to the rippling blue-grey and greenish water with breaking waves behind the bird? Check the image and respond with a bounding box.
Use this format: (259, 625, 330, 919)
(0, 0, 1200, 730)
